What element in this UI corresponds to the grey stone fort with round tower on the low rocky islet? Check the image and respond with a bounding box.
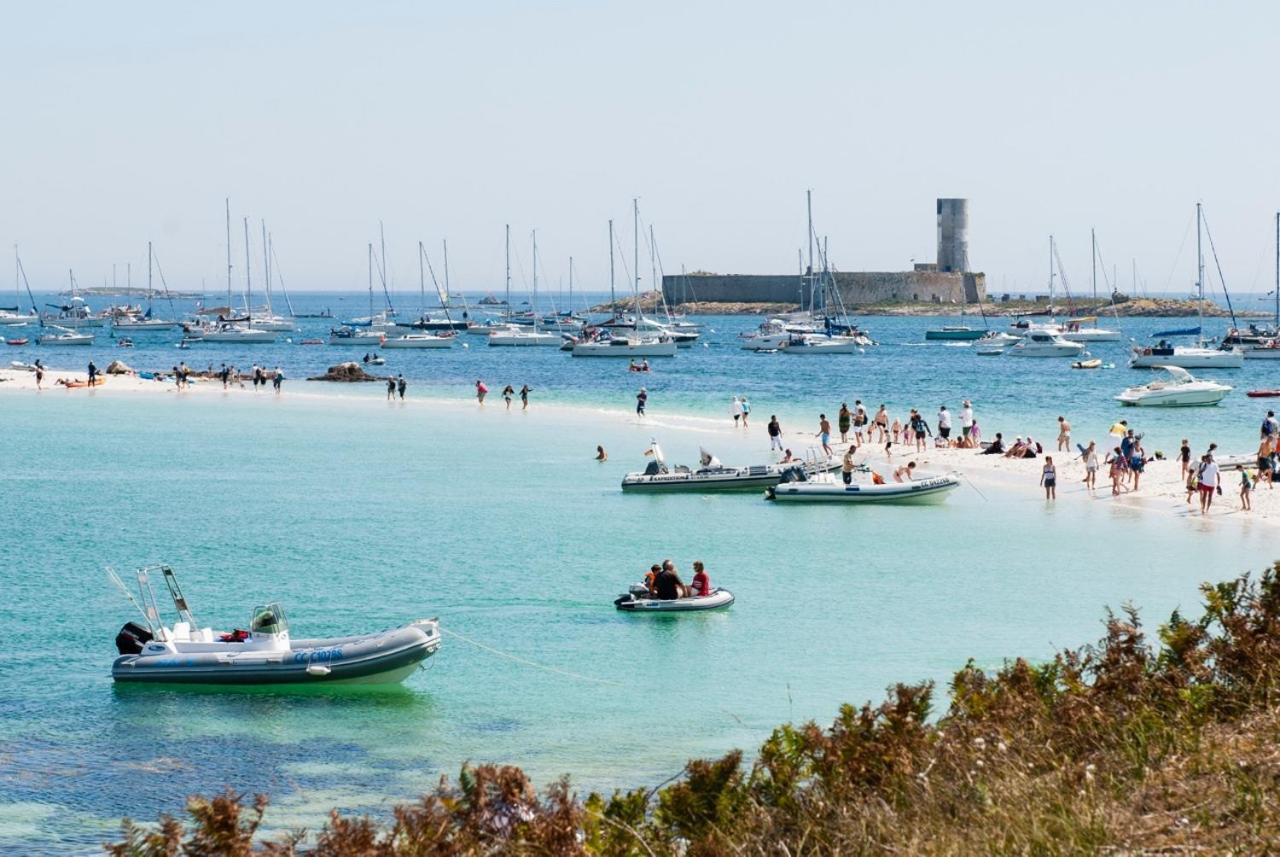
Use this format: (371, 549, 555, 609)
(662, 200, 987, 307)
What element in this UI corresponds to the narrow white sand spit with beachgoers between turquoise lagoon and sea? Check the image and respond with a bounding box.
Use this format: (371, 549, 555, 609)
(0, 368, 1280, 524)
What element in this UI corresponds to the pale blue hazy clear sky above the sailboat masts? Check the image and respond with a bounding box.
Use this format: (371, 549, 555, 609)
(0, 0, 1280, 299)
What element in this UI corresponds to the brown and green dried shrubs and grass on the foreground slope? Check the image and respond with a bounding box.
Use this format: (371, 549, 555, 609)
(108, 564, 1280, 857)
